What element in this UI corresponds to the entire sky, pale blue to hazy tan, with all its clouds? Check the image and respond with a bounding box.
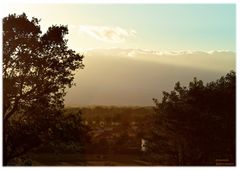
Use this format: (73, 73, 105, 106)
(4, 3, 236, 106)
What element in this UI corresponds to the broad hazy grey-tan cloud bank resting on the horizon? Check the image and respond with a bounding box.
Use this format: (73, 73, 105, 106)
(65, 49, 235, 106)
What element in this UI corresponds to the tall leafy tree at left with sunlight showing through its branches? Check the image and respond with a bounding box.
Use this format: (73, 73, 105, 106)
(3, 13, 84, 165)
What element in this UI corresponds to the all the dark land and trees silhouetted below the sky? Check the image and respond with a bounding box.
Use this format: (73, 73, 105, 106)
(3, 14, 236, 166)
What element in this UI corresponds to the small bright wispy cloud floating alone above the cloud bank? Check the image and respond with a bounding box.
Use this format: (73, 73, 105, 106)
(79, 25, 136, 43)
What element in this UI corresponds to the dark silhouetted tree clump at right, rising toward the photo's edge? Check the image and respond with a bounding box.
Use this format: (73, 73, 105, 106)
(149, 71, 236, 165)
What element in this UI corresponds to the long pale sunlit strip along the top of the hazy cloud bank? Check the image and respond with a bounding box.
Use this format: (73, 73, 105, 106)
(86, 48, 236, 72)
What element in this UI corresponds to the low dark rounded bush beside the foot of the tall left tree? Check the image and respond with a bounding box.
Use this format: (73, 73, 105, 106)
(34, 111, 90, 153)
